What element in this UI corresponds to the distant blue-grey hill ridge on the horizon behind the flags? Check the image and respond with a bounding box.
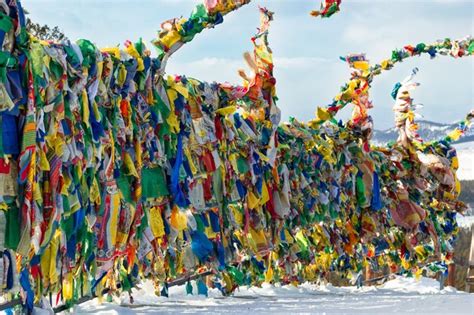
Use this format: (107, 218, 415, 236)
(372, 120, 474, 145)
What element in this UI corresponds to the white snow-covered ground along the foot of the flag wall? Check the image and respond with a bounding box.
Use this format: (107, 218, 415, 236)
(73, 277, 474, 315)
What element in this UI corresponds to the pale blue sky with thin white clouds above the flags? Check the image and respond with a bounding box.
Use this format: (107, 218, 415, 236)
(22, 0, 474, 129)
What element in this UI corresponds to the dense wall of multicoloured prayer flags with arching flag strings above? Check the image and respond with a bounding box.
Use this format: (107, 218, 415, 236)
(0, 0, 474, 311)
